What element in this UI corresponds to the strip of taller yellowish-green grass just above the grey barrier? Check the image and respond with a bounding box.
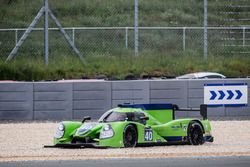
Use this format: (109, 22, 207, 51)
(0, 54, 250, 81)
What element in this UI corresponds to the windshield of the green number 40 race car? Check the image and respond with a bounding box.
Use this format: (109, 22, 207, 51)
(99, 111, 127, 122)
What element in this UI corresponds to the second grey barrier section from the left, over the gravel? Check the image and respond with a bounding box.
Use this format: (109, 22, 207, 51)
(33, 82, 73, 120)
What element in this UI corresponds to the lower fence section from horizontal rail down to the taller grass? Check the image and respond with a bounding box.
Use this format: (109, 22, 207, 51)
(0, 27, 250, 59)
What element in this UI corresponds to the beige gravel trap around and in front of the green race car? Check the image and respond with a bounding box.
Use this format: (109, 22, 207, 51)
(0, 119, 250, 162)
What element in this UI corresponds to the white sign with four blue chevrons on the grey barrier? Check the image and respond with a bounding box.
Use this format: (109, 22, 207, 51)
(204, 83, 248, 106)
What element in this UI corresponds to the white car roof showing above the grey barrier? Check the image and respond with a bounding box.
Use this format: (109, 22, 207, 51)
(176, 72, 226, 79)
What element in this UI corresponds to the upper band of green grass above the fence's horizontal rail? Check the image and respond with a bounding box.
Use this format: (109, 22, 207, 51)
(0, 0, 242, 28)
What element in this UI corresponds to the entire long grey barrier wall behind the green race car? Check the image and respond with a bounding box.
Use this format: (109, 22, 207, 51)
(0, 79, 250, 120)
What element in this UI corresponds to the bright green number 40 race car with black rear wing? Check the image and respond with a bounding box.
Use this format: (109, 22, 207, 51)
(45, 104, 213, 148)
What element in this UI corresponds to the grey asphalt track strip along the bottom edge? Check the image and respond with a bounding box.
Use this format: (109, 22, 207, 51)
(0, 156, 250, 167)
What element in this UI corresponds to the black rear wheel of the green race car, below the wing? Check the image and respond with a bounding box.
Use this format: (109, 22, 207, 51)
(188, 121, 205, 145)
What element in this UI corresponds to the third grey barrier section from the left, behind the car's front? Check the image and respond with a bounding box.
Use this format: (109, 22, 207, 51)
(72, 81, 111, 119)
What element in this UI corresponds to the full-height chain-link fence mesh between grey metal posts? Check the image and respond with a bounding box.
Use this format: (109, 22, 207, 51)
(0, 0, 250, 60)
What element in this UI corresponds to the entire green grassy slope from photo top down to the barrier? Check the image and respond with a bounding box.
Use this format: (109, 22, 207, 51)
(0, 0, 250, 81)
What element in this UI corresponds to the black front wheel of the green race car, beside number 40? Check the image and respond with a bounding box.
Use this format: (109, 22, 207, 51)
(123, 125, 137, 147)
